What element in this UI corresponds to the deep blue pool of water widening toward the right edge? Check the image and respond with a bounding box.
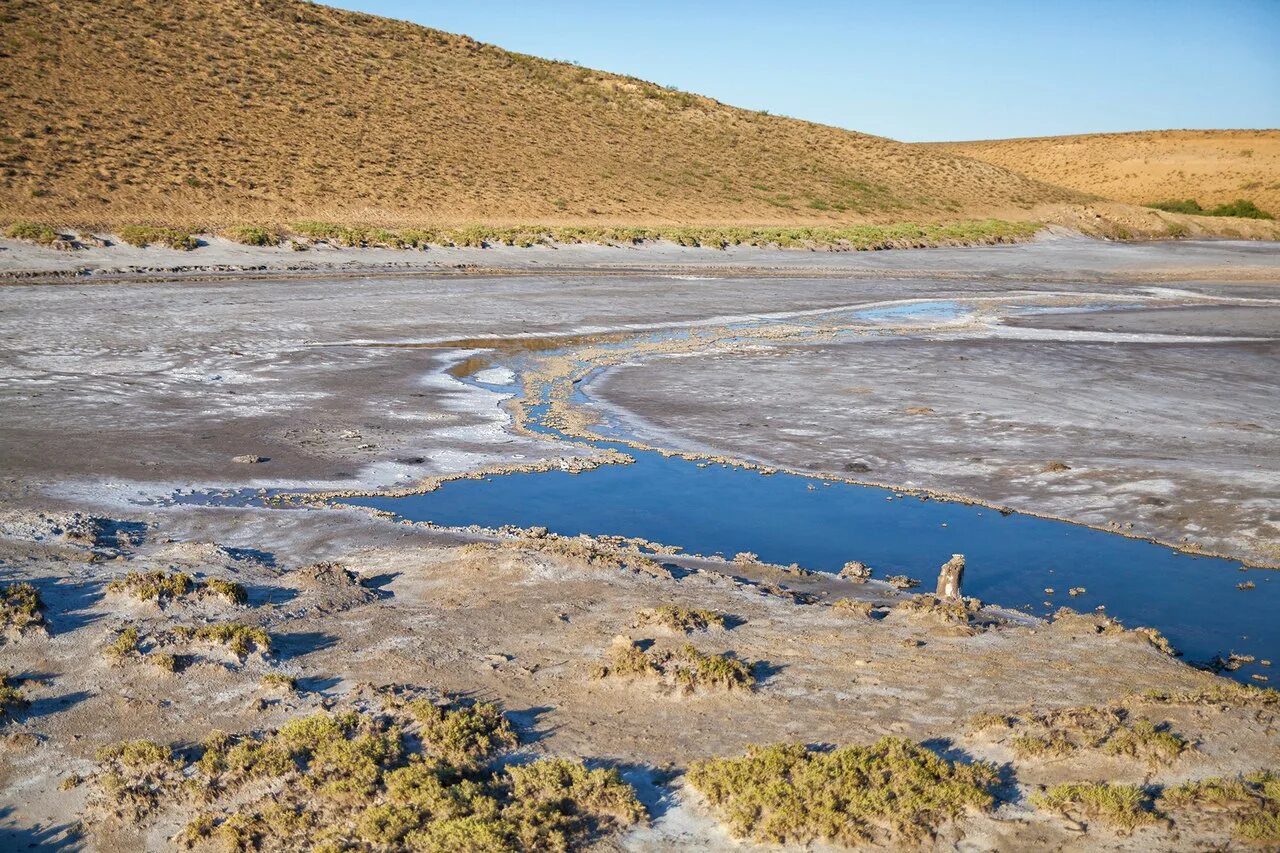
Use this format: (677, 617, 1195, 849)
(343, 438, 1280, 678)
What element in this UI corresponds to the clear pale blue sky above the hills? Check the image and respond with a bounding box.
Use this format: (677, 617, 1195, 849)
(329, 0, 1280, 141)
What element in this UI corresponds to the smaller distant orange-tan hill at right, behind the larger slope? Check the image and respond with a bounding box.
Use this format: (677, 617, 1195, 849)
(920, 131, 1280, 216)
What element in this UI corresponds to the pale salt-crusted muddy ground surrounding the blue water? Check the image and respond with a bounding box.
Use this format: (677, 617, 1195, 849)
(0, 235, 1280, 850)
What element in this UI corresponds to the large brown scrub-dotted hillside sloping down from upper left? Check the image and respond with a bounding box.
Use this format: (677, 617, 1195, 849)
(0, 0, 1076, 227)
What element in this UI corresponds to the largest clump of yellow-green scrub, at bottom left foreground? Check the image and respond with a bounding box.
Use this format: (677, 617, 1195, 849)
(82, 701, 645, 853)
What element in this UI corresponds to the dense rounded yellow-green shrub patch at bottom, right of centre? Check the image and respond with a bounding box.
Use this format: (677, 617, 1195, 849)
(689, 738, 997, 845)
